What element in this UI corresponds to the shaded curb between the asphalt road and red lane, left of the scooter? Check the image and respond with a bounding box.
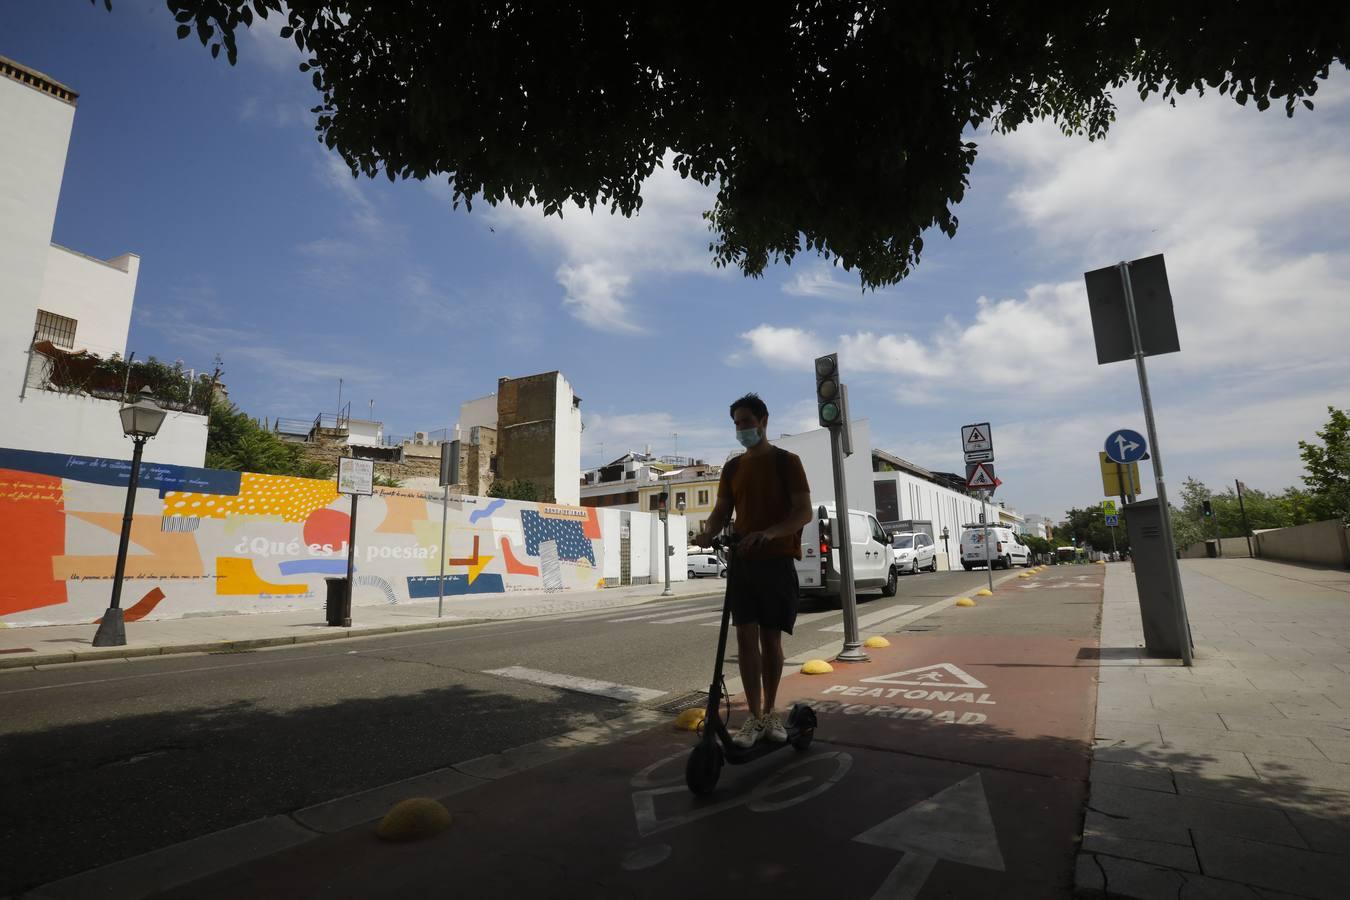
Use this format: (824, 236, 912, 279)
(23, 710, 668, 900)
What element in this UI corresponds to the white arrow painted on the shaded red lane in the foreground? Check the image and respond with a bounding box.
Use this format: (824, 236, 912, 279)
(853, 772, 1004, 900)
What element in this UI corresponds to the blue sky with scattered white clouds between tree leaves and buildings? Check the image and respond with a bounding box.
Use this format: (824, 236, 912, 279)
(0, 0, 1350, 517)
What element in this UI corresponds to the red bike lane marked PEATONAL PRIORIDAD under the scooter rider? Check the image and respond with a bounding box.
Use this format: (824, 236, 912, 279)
(167, 569, 1100, 900)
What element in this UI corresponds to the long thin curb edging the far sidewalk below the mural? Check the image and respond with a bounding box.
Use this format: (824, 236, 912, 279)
(0, 591, 722, 671)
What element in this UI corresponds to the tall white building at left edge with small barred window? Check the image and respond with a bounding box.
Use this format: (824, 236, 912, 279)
(0, 57, 207, 466)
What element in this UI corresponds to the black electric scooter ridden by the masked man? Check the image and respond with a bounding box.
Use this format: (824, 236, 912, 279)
(684, 536, 815, 796)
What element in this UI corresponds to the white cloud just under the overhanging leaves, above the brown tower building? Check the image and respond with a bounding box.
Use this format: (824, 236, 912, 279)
(483, 159, 717, 333)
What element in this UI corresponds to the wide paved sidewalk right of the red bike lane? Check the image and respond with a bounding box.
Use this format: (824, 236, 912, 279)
(1076, 559, 1350, 900)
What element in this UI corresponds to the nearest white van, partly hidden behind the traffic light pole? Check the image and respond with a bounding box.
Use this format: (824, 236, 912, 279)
(797, 503, 896, 598)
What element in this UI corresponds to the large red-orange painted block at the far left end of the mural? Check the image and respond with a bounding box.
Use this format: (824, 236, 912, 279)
(0, 468, 66, 615)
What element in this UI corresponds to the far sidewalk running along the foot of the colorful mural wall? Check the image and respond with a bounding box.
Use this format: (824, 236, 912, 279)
(0, 579, 726, 669)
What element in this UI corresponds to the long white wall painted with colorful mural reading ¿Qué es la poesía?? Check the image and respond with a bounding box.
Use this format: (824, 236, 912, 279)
(0, 449, 631, 626)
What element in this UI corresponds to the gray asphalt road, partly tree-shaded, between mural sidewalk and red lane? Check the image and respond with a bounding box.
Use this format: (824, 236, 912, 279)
(0, 571, 986, 895)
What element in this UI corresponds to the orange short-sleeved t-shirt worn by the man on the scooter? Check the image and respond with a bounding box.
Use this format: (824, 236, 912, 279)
(717, 447, 811, 560)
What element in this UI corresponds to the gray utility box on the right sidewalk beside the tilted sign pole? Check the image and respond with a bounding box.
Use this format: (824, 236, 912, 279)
(1125, 499, 1191, 660)
